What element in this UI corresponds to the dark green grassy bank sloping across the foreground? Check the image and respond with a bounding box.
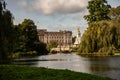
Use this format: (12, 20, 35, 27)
(0, 65, 112, 80)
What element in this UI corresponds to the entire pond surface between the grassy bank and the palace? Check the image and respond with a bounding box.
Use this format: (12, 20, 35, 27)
(14, 53, 120, 80)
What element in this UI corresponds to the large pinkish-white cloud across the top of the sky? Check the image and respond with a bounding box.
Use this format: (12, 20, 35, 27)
(18, 0, 89, 15)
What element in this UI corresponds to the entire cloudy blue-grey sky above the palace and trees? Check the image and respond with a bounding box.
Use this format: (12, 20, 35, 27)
(5, 0, 120, 36)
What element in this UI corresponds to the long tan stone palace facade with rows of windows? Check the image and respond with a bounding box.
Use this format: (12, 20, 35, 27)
(37, 29, 72, 46)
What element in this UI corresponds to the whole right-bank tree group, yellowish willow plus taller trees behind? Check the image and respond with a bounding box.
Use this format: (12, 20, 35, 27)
(79, 0, 120, 54)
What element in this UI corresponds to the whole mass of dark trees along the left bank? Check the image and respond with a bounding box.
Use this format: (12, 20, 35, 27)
(0, 0, 48, 64)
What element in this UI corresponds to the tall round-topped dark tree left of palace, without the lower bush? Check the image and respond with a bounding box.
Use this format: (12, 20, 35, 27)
(19, 19, 39, 52)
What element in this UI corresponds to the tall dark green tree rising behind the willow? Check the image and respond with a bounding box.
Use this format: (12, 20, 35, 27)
(84, 0, 111, 23)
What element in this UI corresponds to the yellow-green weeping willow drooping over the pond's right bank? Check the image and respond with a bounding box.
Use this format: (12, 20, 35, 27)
(79, 21, 120, 54)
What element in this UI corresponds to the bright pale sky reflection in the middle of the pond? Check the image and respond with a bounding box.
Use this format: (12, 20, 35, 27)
(36, 54, 89, 72)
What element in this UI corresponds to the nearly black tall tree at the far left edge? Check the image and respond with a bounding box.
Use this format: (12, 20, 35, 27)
(0, 0, 15, 63)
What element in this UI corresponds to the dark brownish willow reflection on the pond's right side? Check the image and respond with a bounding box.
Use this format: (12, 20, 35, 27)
(89, 57, 120, 80)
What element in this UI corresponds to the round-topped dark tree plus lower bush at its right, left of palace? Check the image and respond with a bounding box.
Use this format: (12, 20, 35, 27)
(14, 19, 47, 55)
